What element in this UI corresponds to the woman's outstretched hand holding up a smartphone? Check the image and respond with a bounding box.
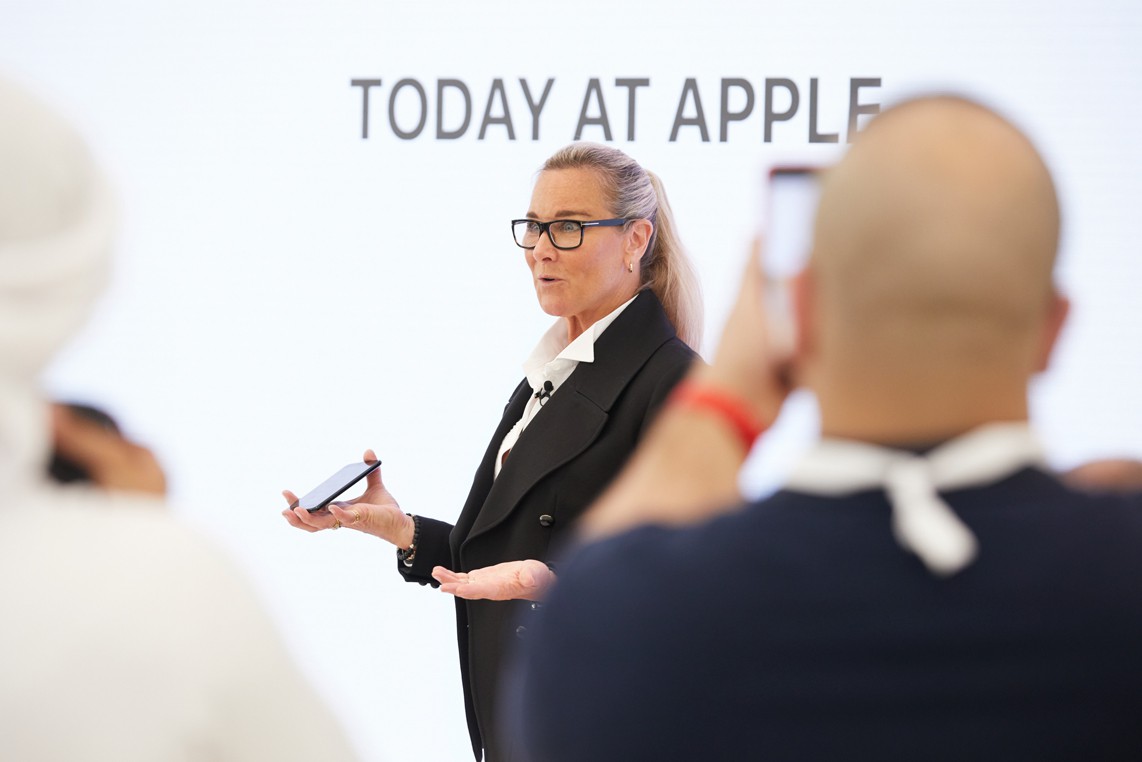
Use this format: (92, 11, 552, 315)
(282, 450, 415, 548)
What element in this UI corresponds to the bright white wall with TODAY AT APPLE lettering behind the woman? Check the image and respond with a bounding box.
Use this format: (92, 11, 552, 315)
(0, 0, 1142, 760)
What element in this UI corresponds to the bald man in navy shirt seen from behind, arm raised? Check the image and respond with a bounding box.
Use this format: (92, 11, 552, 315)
(512, 97, 1142, 762)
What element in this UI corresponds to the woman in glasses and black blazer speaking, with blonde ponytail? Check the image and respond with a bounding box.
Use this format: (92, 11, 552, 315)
(283, 143, 701, 762)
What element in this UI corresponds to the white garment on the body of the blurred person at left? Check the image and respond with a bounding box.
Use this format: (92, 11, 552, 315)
(0, 488, 356, 762)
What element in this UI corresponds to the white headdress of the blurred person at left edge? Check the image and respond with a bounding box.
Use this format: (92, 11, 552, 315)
(0, 78, 115, 489)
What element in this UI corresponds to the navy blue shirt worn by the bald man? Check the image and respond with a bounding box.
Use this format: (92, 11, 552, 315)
(506, 468, 1142, 762)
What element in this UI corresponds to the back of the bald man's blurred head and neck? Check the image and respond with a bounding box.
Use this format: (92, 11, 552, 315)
(801, 97, 1065, 443)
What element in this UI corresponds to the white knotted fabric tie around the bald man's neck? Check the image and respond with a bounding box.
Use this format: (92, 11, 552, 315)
(786, 422, 1046, 576)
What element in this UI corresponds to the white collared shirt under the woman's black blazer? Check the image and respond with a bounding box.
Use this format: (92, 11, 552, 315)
(494, 294, 638, 476)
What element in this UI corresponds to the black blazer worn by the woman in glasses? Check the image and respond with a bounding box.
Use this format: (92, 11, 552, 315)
(396, 291, 695, 761)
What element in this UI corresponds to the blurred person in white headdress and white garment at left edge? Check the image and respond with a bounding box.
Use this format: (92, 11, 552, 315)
(0, 78, 354, 762)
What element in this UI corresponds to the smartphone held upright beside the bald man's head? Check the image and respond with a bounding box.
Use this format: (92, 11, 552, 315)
(762, 166, 821, 352)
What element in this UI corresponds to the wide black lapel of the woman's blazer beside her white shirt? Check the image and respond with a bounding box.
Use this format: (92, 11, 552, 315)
(460, 291, 675, 542)
